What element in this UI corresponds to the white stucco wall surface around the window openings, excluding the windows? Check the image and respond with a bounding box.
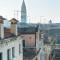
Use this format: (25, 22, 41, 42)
(0, 37, 23, 60)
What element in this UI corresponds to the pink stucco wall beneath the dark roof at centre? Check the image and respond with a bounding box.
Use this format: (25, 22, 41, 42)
(21, 34, 35, 47)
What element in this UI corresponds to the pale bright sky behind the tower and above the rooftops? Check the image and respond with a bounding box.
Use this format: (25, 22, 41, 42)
(0, 0, 60, 23)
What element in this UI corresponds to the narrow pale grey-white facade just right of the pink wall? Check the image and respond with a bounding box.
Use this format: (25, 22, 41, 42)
(36, 27, 46, 60)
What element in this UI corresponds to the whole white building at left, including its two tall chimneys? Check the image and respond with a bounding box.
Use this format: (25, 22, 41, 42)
(0, 16, 23, 60)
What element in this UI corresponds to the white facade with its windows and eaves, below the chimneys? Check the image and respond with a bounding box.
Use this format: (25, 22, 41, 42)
(0, 36, 23, 60)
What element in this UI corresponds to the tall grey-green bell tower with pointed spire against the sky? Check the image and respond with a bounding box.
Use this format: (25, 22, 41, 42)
(21, 0, 27, 23)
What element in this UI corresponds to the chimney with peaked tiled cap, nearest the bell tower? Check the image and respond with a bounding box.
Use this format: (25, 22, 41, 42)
(10, 18, 18, 36)
